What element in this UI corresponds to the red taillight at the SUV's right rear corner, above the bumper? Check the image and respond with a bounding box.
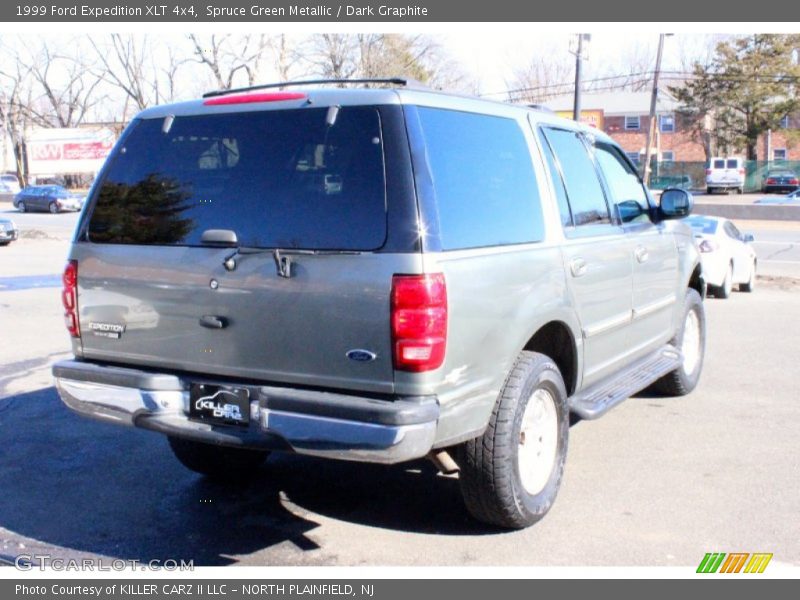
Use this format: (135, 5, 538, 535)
(391, 273, 447, 373)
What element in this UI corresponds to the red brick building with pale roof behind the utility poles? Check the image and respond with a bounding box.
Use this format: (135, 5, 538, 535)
(545, 91, 800, 164)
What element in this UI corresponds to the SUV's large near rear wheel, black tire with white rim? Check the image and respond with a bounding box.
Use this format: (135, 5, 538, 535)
(458, 352, 569, 529)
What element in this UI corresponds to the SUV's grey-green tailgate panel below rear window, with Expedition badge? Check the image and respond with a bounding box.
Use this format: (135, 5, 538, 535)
(73, 244, 405, 393)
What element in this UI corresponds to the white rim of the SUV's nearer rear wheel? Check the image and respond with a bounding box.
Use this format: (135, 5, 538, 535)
(517, 389, 558, 494)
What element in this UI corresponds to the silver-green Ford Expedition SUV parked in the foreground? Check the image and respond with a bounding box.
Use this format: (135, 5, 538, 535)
(53, 77, 705, 527)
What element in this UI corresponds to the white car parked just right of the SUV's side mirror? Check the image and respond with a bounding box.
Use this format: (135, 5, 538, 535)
(685, 215, 758, 298)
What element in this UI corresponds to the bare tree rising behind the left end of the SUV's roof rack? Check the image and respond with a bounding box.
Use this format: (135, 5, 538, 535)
(189, 33, 274, 90)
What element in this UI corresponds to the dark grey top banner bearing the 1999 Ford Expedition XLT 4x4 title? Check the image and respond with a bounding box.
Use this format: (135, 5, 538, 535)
(0, 0, 800, 23)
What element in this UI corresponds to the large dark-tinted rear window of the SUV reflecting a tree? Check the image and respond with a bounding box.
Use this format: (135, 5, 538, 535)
(89, 107, 386, 250)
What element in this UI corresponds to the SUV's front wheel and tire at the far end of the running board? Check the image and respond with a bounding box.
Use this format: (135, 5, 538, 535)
(653, 288, 706, 396)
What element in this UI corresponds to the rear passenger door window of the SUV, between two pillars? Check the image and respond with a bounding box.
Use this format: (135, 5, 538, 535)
(543, 128, 611, 227)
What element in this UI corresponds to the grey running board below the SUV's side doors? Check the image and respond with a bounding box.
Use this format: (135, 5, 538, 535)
(569, 344, 683, 419)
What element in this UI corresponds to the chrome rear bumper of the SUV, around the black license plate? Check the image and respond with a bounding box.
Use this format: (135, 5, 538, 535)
(53, 361, 439, 463)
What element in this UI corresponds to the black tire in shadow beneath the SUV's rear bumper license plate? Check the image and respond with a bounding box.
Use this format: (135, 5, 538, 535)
(168, 436, 269, 480)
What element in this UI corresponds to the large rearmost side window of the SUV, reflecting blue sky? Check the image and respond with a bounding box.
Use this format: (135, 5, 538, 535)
(417, 107, 544, 250)
